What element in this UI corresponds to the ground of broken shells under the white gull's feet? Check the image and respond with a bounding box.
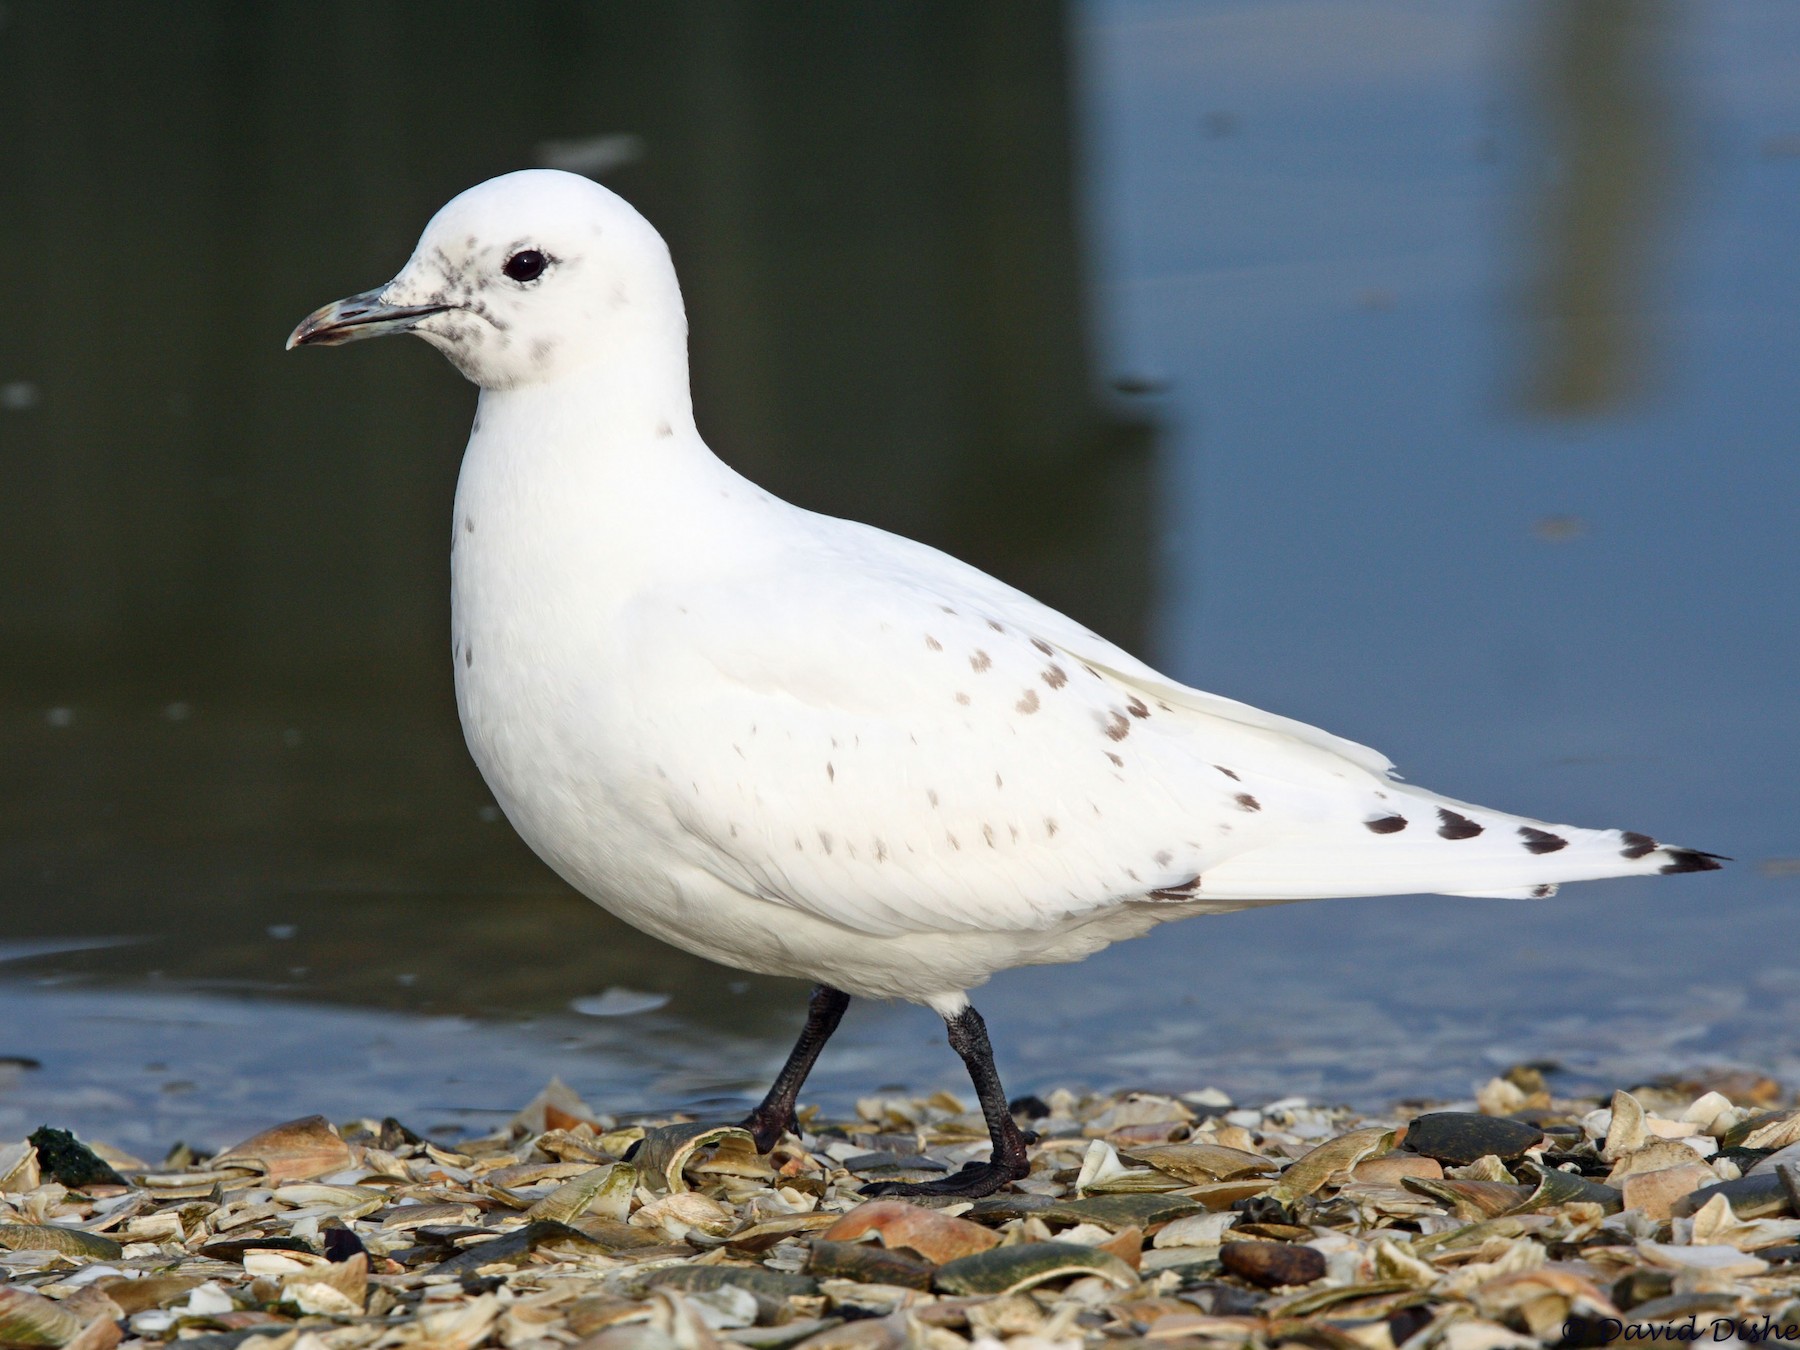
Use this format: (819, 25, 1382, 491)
(0, 1067, 1800, 1350)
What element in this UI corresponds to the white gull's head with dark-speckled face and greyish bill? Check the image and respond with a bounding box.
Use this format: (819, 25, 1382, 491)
(288, 169, 686, 389)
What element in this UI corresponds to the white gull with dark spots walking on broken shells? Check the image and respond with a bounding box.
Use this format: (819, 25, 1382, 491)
(288, 169, 1719, 1195)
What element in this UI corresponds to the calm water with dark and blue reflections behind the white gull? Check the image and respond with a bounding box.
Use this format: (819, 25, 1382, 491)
(0, 0, 1800, 1148)
